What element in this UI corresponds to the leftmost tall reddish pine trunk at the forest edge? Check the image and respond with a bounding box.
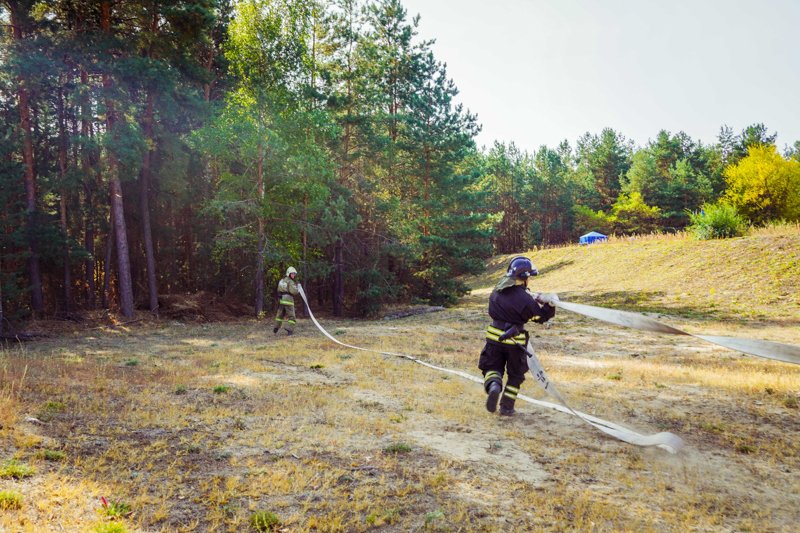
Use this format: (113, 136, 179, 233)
(8, 2, 44, 315)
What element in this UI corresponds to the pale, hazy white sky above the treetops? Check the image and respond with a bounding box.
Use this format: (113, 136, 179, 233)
(402, 0, 800, 151)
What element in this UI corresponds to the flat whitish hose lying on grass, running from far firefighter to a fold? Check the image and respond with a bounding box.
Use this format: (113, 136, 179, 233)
(297, 286, 683, 453)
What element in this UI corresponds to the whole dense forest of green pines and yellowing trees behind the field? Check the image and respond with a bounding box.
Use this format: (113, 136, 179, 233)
(0, 0, 800, 324)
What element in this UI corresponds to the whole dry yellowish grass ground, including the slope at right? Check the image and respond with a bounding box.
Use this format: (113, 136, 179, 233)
(0, 226, 800, 532)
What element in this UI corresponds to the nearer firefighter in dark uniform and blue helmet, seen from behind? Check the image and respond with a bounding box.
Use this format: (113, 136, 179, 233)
(478, 257, 558, 416)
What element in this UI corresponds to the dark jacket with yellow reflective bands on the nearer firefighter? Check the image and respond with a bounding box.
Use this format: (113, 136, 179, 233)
(486, 285, 556, 344)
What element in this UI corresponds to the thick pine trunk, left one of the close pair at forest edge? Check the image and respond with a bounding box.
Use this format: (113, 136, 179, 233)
(100, 0, 133, 318)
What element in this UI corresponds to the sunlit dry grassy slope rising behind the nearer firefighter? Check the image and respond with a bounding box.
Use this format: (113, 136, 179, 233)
(470, 225, 800, 334)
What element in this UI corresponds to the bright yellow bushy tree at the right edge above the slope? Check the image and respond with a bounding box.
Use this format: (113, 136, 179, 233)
(725, 145, 800, 224)
